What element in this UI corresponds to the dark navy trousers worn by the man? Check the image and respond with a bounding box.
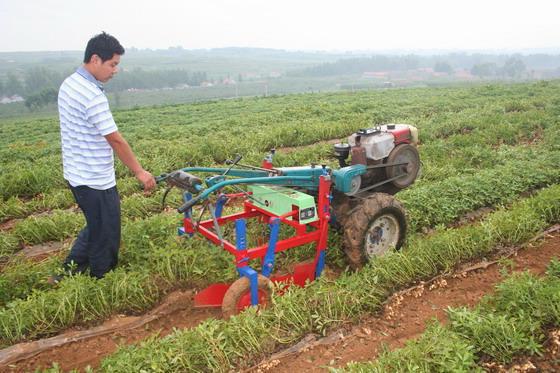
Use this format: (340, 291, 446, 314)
(64, 185, 121, 278)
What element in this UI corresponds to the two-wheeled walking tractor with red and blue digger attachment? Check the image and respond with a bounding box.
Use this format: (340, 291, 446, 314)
(157, 124, 420, 317)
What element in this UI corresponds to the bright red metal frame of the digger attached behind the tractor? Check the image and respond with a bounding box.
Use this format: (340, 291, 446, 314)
(191, 175, 331, 307)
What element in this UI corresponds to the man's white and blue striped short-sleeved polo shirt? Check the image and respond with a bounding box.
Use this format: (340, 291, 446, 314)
(58, 67, 117, 190)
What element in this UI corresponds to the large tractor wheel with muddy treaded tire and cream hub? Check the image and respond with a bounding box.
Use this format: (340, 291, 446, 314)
(344, 193, 406, 269)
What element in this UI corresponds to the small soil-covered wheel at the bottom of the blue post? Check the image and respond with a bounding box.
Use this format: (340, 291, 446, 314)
(222, 275, 272, 319)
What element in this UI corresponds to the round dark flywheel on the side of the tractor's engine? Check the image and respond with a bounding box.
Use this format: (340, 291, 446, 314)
(385, 144, 420, 190)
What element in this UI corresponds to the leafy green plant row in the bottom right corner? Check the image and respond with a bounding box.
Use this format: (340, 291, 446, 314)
(340, 259, 560, 373)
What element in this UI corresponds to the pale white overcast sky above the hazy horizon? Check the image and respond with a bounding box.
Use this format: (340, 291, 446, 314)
(0, 0, 560, 53)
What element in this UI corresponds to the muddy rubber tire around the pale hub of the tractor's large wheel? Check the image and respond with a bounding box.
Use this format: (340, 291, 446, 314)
(344, 193, 407, 269)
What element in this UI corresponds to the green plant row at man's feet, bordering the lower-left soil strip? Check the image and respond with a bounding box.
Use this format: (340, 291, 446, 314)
(0, 231, 234, 347)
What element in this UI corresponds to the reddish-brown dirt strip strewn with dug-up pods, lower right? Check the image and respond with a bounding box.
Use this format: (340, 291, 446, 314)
(253, 228, 560, 373)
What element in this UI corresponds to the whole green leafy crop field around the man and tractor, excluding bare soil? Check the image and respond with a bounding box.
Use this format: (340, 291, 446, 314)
(0, 81, 560, 372)
